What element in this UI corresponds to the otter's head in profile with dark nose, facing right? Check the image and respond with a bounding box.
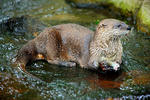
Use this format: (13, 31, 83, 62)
(97, 19, 131, 38)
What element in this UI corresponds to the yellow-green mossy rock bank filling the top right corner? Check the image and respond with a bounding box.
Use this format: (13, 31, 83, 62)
(66, 0, 150, 34)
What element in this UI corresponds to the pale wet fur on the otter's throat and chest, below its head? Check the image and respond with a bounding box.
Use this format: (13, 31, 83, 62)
(89, 24, 123, 63)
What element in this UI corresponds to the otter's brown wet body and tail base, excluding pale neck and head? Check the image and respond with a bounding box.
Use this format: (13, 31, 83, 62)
(16, 24, 94, 67)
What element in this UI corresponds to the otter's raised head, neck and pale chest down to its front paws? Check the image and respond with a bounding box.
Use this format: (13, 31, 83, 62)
(89, 19, 131, 70)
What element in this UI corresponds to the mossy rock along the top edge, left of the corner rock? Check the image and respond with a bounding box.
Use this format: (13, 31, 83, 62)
(66, 0, 142, 13)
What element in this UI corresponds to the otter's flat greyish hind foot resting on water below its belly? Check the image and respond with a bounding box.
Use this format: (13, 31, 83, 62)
(48, 60, 76, 67)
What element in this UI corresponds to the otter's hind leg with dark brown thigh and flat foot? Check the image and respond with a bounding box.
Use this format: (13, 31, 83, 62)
(46, 28, 76, 67)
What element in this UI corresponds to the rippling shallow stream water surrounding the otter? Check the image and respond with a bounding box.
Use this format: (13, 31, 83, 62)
(0, 0, 150, 100)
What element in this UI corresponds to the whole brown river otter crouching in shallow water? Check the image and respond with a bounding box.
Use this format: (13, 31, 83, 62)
(16, 19, 131, 70)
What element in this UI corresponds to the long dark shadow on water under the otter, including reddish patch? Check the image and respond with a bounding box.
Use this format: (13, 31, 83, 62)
(26, 60, 126, 89)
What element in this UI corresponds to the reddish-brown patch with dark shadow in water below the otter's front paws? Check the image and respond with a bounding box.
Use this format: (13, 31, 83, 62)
(86, 70, 126, 89)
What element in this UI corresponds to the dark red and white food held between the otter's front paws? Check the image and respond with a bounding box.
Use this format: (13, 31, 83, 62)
(99, 62, 120, 72)
